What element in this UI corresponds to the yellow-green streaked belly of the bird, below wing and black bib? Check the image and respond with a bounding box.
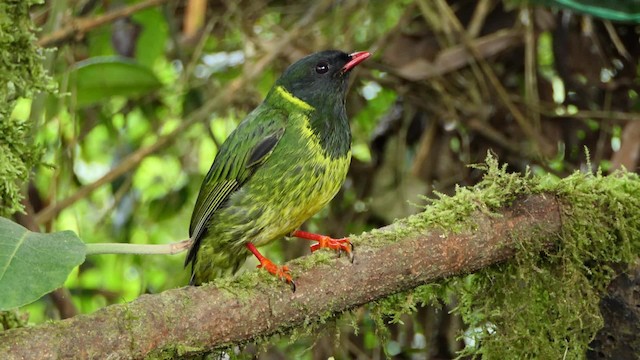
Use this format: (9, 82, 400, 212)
(215, 146, 351, 246)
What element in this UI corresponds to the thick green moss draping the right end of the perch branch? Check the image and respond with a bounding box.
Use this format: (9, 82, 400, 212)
(372, 156, 640, 359)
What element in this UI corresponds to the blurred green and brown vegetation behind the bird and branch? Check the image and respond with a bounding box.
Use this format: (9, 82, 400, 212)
(0, 0, 640, 359)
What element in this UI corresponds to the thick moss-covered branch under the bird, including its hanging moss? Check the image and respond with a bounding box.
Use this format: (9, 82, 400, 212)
(0, 161, 640, 359)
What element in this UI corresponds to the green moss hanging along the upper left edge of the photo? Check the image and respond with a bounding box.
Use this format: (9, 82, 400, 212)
(0, 0, 53, 216)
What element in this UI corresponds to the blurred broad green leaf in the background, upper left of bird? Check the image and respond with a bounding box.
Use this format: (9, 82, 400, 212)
(69, 56, 162, 107)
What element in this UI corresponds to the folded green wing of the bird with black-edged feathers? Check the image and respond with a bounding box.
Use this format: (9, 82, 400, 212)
(185, 104, 287, 265)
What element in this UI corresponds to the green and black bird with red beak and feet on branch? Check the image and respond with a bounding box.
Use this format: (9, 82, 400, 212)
(184, 50, 371, 292)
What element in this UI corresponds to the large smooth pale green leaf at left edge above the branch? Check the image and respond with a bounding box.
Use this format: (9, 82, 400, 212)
(0, 217, 86, 311)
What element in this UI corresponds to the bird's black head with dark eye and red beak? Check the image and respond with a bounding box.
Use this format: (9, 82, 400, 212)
(276, 50, 371, 110)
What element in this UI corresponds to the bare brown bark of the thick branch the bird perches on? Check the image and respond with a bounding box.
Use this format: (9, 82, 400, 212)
(0, 195, 561, 359)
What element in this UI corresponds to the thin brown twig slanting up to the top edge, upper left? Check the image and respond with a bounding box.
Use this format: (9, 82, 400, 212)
(38, 0, 169, 47)
